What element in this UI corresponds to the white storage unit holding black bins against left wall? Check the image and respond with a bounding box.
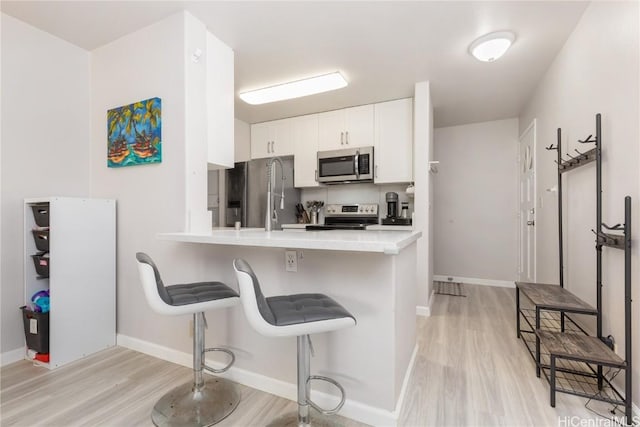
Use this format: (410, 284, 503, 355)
(23, 197, 115, 369)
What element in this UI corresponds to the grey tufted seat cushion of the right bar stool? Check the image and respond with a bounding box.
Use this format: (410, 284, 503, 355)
(267, 294, 353, 326)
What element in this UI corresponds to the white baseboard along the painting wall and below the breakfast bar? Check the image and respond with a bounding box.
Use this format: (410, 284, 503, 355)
(116, 334, 402, 427)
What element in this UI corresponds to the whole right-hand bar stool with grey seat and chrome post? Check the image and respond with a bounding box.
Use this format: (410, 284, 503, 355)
(233, 259, 356, 426)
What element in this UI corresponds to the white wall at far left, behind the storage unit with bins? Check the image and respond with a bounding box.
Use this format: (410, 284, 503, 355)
(0, 14, 90, 363)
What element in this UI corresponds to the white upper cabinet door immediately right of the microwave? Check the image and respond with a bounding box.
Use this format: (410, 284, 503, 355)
(374, 98, 413, 184)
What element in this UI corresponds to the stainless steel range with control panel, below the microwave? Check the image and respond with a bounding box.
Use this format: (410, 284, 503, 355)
(306, 203, 378, 230)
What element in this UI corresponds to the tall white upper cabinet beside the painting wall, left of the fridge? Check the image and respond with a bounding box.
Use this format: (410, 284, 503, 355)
(205, 31, 235, 169)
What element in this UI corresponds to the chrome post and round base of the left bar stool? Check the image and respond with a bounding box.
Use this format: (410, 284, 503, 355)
(151, 313, 240, 427)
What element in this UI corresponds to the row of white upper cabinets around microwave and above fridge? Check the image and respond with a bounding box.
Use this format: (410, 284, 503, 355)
(251, 98, 413, 187)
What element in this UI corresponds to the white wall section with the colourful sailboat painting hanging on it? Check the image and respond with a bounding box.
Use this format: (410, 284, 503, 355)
(91, 14, 218, 351)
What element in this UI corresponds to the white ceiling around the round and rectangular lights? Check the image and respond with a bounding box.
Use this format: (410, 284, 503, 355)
(0, 0, 588, 127)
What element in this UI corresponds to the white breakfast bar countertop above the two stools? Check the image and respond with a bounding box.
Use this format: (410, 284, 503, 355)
(157, 228, 422, 255)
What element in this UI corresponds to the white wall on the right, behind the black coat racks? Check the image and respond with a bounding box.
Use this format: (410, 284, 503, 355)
(520, 2, 640, 402)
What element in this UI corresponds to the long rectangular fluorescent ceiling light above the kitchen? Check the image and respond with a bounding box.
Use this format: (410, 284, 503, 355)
(240, 71, 347, 105)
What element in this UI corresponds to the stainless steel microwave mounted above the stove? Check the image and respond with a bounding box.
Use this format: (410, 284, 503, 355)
(318, 147, 373, 184)
